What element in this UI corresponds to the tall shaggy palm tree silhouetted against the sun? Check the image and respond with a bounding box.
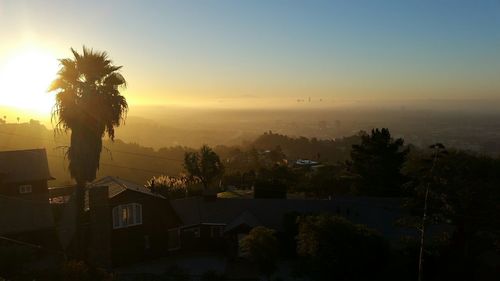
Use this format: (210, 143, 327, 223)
(48, 46, 128, 257)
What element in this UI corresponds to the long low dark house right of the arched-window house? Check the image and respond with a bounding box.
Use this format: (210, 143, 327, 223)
(170, 197, 415, 255)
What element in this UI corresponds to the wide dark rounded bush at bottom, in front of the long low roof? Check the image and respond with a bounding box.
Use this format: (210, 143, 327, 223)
(297, 214, 389, 280)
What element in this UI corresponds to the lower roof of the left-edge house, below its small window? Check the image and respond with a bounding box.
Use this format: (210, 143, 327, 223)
(0, 196, 54, 235)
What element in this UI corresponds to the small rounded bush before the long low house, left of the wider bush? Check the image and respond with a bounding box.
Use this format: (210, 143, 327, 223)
(240, 226, 278, 278)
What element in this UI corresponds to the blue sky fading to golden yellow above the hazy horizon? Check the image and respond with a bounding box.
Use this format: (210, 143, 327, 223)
(0, 0, 500, 110)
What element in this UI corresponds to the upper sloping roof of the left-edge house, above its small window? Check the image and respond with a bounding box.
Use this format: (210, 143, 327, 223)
(0, 149, 54, 183)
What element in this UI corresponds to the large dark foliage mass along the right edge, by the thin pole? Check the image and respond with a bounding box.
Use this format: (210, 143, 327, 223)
(405, 145, 500, 279)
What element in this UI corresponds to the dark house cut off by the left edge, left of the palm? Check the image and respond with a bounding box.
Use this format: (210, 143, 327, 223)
(0, 149, 58, 247)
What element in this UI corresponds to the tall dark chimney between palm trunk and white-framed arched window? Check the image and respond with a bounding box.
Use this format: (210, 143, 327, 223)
(88, 186, 112, 268)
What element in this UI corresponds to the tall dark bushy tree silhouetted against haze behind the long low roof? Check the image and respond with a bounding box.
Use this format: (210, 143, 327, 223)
(350, 128, 409, 196)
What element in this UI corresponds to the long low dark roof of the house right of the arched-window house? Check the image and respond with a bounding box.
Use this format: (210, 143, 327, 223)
(171, 197, 413, 237)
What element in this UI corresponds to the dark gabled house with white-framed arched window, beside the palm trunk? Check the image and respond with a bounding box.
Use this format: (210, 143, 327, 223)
(51, 176, 180, 267)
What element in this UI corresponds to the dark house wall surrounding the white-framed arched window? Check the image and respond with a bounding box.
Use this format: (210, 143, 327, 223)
(109, 190, 180, 266)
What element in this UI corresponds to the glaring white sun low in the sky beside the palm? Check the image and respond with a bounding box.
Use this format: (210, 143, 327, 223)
(0, 50, 59, 113)
